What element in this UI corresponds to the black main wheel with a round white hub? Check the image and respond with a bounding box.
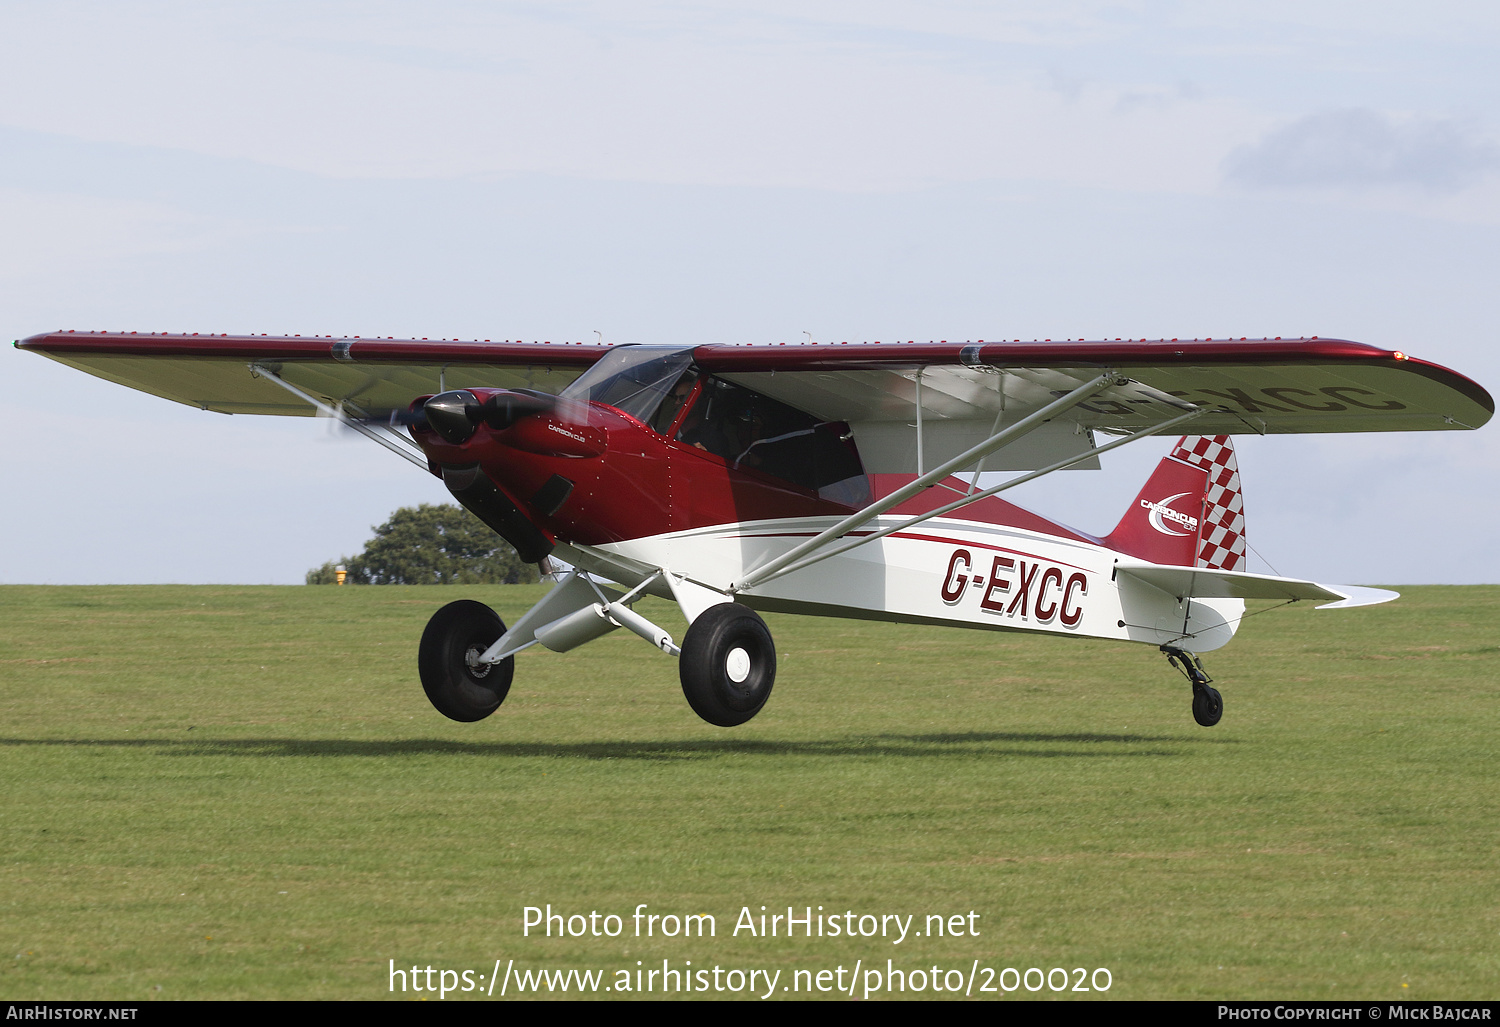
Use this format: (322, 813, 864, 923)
(678, 603, 776, 727)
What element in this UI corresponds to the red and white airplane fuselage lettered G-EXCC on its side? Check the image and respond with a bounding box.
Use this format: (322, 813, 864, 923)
(414, 390, 1244, 651)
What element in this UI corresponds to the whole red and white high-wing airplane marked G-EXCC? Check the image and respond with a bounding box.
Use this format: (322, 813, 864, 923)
(17, 331, 1494, 726)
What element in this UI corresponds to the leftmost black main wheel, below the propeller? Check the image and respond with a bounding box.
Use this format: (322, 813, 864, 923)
(417, 600, 516, 723)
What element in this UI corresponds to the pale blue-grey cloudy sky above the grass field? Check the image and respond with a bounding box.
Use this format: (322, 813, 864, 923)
(0, 0, 1500, 585)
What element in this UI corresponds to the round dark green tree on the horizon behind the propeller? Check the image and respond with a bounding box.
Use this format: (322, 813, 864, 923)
(306, 502, 537, 585)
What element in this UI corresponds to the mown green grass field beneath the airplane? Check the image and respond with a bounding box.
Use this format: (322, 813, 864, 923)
(0, 586, 1500, 1002)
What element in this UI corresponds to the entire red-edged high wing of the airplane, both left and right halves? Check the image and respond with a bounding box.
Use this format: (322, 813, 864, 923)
(17, 331, 1494, 474)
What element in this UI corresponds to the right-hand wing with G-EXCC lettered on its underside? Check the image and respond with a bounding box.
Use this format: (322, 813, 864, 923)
(695, 339, 1494, 472)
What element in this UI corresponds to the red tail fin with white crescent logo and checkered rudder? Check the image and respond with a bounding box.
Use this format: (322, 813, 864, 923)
(1104, 435, 1245, 571)
